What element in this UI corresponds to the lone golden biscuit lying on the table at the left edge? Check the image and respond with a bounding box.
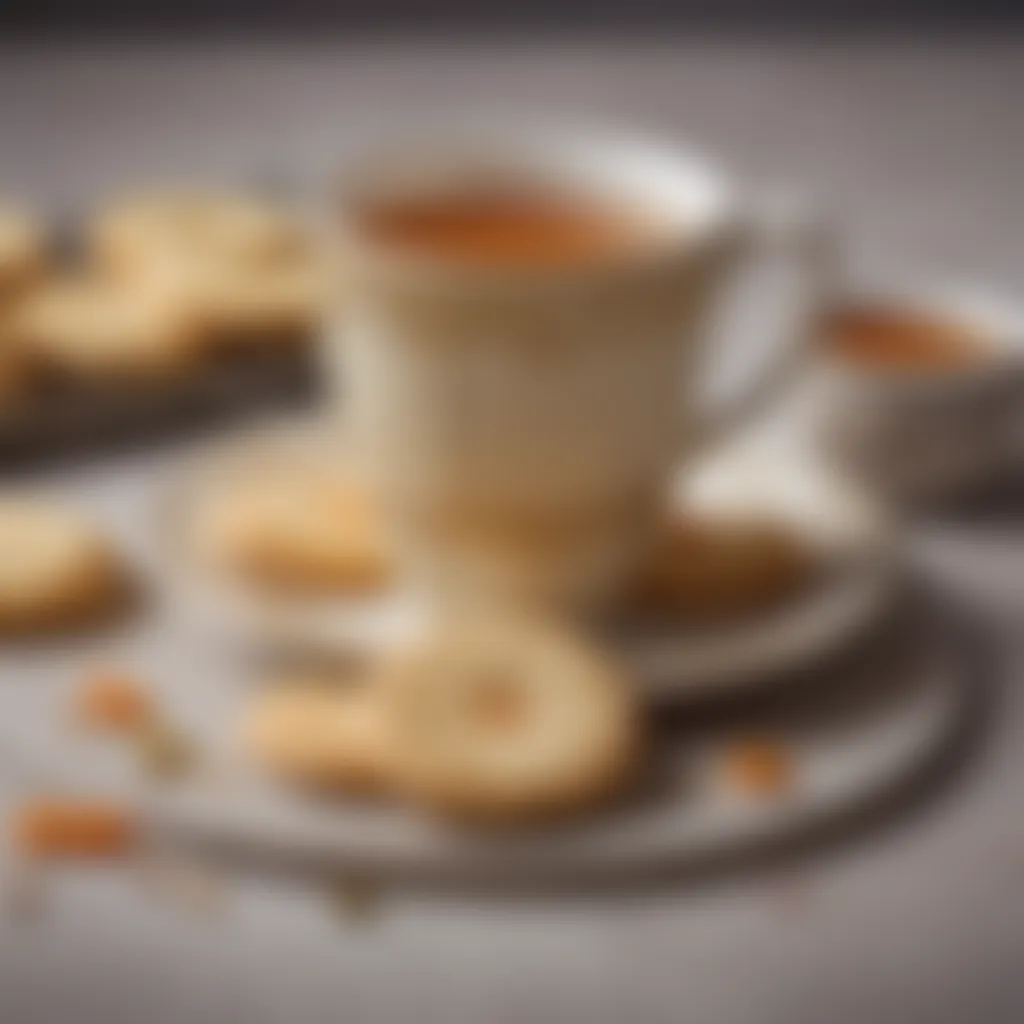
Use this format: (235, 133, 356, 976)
(0, 499, 125, 633)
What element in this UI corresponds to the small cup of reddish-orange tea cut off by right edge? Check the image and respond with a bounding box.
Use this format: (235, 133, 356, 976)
(812, 278, 1024, 500)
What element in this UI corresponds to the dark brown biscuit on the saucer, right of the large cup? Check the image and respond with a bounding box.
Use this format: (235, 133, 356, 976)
(640, 514, 814, 621)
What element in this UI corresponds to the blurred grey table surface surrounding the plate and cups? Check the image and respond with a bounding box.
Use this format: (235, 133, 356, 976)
(0, 40, 1024, 1024)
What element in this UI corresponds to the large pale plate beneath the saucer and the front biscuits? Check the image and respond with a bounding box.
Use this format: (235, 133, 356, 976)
(143, 594, 966, 885)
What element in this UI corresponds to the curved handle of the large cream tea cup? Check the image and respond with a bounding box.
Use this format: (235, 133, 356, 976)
(689, 196, 835, 450)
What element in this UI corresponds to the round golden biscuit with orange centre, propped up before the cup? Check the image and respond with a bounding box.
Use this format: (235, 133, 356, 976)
(382, 622, 641, 824)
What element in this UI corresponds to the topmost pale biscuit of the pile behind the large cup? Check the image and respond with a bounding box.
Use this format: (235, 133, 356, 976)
(89, 191, 309, 273)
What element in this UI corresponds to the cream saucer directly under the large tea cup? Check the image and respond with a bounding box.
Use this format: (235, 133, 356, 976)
(152, 424, 896, 701)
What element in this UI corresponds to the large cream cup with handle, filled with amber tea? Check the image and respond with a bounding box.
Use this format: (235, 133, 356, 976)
(329, 131, 820, 607)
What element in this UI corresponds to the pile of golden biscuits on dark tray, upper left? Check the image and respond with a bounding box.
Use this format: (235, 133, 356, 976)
(0, 193, 324, 404)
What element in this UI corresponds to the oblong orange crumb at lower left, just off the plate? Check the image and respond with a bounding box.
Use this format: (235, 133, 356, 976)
(12, 799, 135, 858)
